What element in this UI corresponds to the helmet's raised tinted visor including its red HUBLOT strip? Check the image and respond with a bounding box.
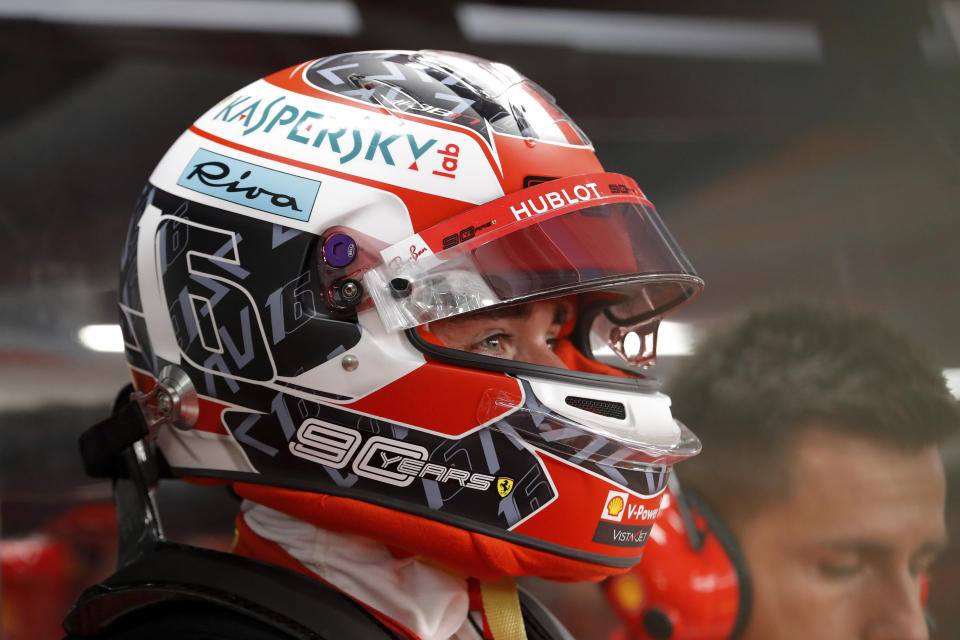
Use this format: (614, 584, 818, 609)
(365, 174, 703, 340)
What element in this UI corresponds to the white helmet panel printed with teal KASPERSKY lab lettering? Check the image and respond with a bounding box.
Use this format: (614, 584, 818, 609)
(176, 80, 503, 204)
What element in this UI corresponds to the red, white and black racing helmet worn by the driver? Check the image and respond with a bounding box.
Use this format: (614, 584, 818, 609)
(120, 51, 702, 579)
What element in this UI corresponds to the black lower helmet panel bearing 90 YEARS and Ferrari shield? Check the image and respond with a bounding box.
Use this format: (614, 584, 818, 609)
(216, 385, 556, 536)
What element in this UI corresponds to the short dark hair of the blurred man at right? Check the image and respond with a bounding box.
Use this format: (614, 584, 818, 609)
(666, 303, 960, 520)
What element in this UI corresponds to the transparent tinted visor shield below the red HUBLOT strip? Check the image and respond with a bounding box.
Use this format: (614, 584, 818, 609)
(366, 196, 703, 329)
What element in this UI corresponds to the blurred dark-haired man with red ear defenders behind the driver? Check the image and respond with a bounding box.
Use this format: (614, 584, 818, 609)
(606, 305, 960, 640)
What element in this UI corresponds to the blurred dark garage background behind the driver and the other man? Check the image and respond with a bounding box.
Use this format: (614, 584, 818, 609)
(0, 0, 960, 640)
